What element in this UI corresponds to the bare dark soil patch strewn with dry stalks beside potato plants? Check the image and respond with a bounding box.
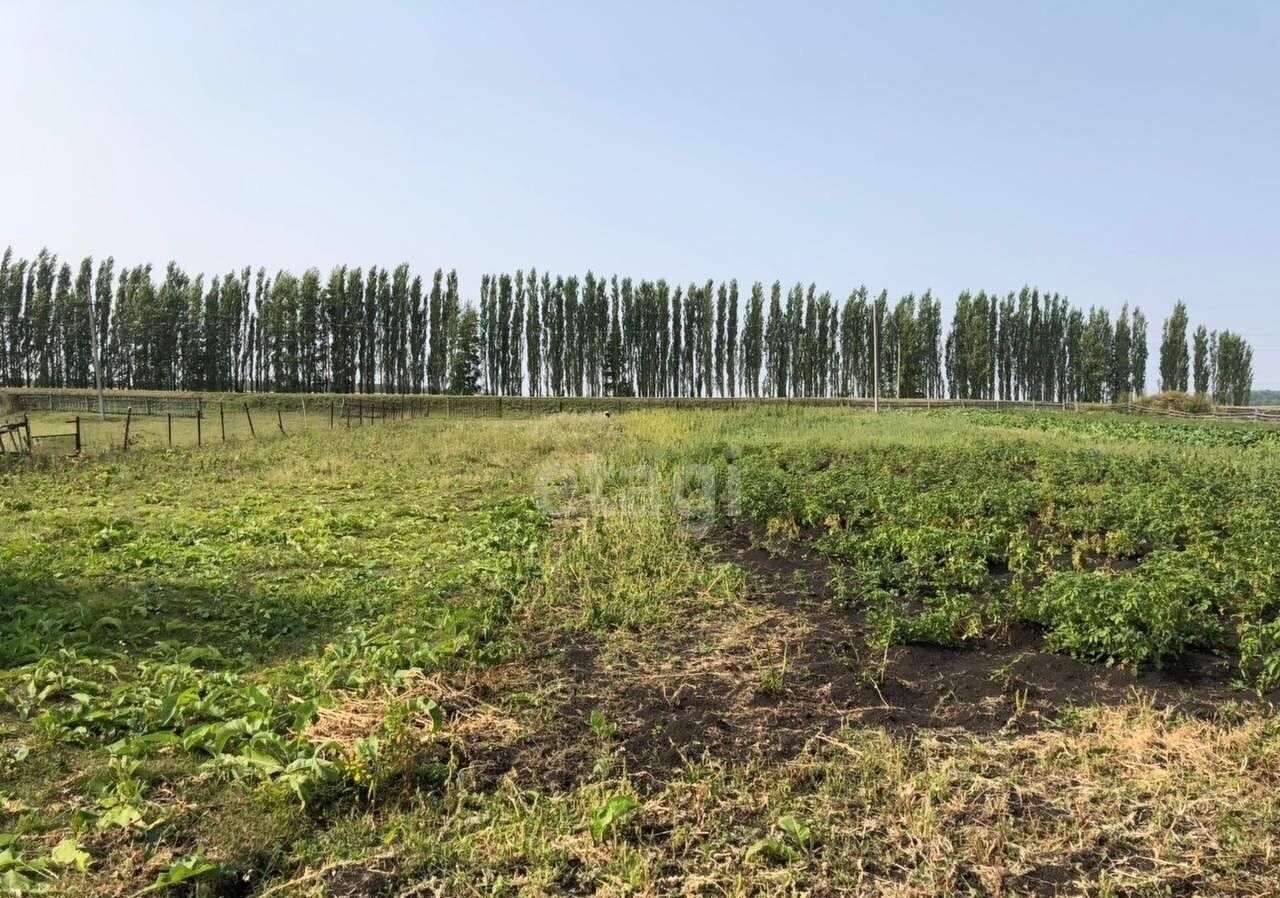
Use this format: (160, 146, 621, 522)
(475, 526, 1264, 793)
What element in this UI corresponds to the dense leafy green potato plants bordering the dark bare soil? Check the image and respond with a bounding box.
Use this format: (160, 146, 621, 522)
(737, 413, 1280, 689)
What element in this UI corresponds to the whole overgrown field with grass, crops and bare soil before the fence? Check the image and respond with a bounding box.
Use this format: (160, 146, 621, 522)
(0, 407, 1280, 898)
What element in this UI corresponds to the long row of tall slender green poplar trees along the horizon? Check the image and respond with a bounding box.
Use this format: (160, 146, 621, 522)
(0, 249, 1252, 404)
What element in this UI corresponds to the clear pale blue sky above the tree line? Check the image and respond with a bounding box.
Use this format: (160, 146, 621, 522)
(0, 0, 1280, 388)
